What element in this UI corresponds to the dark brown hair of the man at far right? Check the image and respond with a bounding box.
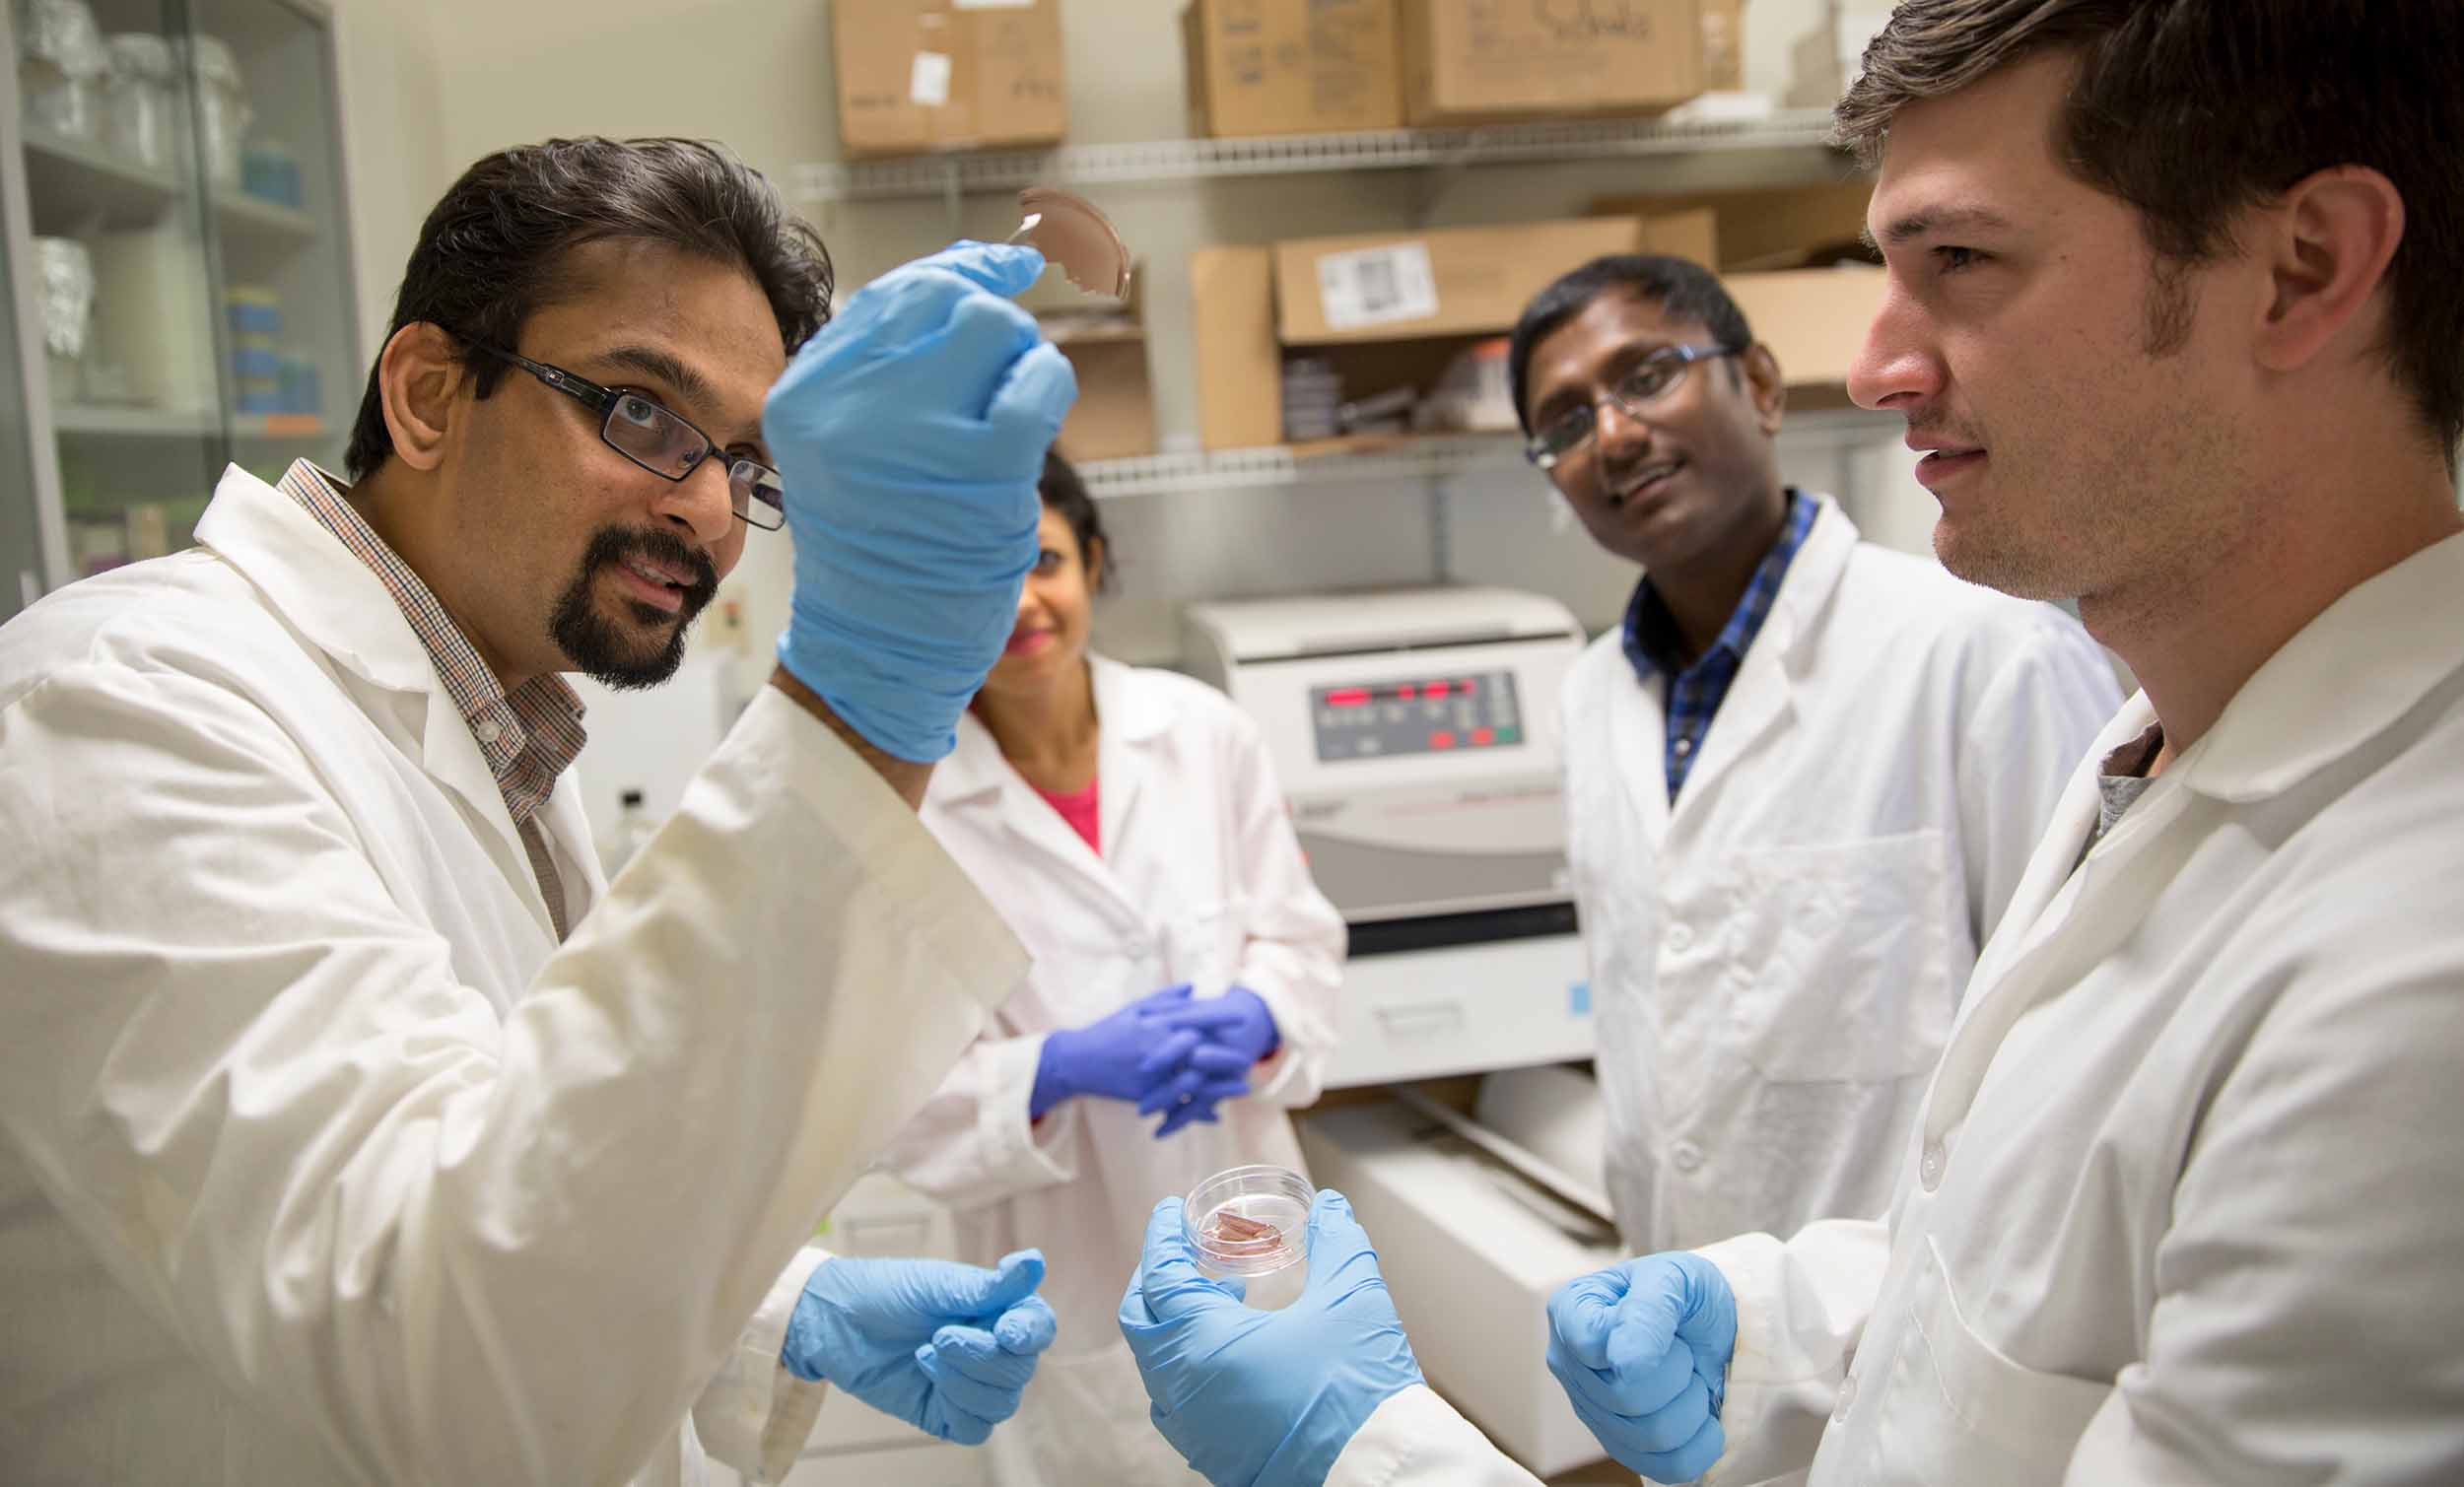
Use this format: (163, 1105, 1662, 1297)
(1836, 0, 2464, 470)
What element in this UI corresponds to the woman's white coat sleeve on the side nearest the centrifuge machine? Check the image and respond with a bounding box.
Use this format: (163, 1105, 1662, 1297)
(1225, 714, 1345, 1111)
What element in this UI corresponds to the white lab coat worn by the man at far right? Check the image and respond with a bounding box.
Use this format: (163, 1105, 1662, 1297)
(1329, 537, 2464, 1487)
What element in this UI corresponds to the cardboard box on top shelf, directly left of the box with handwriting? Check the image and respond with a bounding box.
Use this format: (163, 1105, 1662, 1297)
(1181, 0, 1403, 135)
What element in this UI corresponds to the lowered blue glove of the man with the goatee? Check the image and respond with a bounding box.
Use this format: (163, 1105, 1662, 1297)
(779, 1250, 1053, 1446)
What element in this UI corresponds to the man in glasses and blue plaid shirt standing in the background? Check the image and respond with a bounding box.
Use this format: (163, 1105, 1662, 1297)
(1508, 256, 2122, 1250)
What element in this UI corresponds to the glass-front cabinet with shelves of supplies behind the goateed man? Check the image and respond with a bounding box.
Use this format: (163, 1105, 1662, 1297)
(0, 0, 363, 618)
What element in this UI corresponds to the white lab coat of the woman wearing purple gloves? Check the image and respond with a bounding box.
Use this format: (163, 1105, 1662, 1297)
(887, 657, 1343, 1487)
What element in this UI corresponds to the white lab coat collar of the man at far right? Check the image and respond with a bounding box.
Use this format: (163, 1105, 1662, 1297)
(2181, 534, 2464, 802)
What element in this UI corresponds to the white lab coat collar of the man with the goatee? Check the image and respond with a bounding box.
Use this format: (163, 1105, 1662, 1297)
(197, 465, 448, 699)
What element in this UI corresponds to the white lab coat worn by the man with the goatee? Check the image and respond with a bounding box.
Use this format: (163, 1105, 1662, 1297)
(0, 470, 1023, 1487)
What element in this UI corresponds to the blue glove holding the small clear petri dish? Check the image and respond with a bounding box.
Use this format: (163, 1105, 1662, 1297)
(1122, 1189, 1422, 1487)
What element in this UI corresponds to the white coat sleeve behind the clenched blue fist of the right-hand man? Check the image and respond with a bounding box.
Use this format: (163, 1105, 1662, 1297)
(1695, 1219, 1890, 1487)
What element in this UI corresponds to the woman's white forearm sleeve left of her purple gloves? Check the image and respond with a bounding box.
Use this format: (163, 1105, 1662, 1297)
(880, 1034, 1082, 1211)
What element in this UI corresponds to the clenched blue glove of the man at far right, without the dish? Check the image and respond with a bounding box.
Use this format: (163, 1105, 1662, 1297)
(1547, 1250, 1738, 1482)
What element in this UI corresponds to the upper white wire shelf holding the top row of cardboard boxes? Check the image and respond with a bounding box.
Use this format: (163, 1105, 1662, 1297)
(791, 108, 1831, 202)
